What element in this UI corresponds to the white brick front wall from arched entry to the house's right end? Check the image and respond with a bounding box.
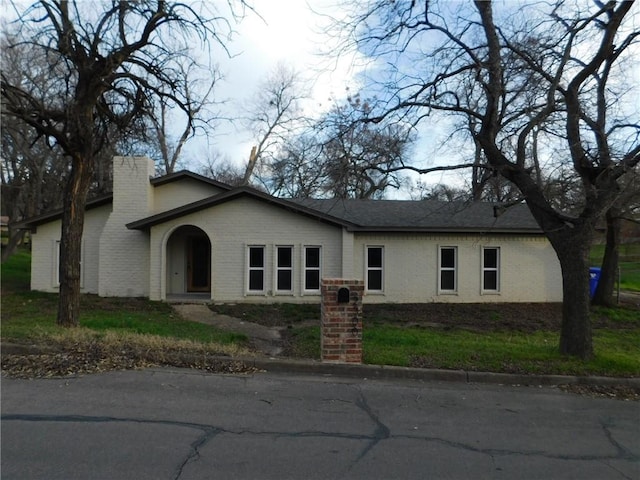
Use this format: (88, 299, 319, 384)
(150, 198, 562, 303)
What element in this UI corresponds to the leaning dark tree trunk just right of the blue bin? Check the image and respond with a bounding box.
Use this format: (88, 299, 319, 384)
(592, 206, 621, 306)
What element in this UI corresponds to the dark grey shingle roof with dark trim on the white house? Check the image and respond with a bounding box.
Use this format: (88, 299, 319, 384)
(21, 164, 542, 235)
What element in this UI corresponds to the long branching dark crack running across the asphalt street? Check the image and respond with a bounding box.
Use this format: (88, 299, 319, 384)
(0, 410, 640, 470)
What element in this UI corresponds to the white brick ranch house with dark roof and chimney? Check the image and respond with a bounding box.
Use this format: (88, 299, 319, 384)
(23, 157, 562, 303)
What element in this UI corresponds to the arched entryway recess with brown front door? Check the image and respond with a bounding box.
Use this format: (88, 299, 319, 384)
(166, 225, 211, 296)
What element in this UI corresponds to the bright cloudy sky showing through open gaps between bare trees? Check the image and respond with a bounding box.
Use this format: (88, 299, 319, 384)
(5, 0, 640, 195)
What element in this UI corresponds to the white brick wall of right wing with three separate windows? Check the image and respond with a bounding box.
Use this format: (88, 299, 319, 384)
(353, 234, 562, 303)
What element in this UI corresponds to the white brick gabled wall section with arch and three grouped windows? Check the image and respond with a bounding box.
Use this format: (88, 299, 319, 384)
(150, 198, 342, 302)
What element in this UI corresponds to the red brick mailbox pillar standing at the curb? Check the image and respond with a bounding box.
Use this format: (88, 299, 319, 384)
(321, 278, 364, 363)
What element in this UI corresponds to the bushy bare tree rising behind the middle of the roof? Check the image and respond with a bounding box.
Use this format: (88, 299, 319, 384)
(264, 95, 414, 198)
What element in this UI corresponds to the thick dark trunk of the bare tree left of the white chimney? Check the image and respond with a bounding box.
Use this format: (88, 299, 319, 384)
(57, 157, 93, 327)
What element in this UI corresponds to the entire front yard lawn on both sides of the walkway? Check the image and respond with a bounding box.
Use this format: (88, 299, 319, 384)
(1, 248, 640, 376)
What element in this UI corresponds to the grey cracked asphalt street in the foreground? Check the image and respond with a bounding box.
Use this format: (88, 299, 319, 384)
(1, 369, 640, 480)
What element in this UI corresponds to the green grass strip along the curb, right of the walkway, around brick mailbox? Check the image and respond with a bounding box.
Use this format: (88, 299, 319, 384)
(290, 321, 640, 377)
